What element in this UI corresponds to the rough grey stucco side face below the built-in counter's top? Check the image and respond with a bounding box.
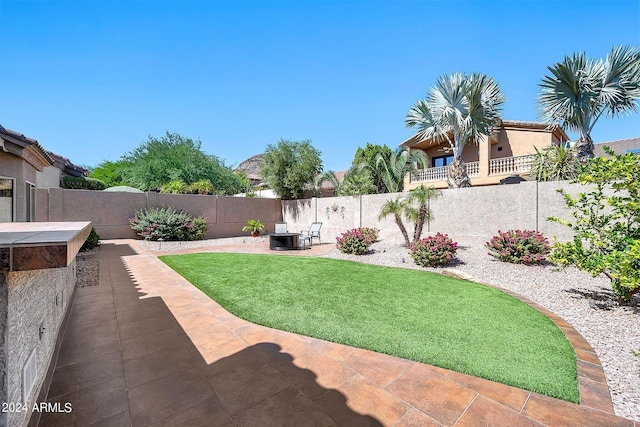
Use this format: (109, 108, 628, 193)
(0, 260, 76, 427)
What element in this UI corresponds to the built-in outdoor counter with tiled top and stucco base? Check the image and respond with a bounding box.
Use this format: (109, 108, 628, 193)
(0, 222, 91, 427)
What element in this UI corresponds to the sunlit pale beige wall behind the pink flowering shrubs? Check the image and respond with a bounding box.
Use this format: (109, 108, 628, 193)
(282, 181, 585, 246)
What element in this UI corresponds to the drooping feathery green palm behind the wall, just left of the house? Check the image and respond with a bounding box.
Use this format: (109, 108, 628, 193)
(376, 150, 428, 193)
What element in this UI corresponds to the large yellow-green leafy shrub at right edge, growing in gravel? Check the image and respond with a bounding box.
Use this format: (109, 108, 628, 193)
(549, 147, 640, 303)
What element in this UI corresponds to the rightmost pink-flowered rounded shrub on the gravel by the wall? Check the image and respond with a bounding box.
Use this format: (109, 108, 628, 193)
(485, 230, 551, 264)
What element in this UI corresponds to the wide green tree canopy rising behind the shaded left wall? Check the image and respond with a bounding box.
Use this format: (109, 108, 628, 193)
(116, 132, 242, 194)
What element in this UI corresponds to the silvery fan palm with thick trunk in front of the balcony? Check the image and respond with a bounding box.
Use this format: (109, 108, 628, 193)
(405, 73, 505, 188)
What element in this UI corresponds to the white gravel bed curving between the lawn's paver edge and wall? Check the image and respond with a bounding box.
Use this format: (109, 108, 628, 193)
(327, 236, 640, 421)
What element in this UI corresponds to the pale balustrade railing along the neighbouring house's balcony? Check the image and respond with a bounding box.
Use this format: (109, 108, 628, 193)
(411, 154, 535, 182)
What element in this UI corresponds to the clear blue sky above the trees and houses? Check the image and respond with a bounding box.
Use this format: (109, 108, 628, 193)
(0, 0, 640, 170)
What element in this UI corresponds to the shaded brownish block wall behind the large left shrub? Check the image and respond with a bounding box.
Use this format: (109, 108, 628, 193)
(36, 188, 282, 239)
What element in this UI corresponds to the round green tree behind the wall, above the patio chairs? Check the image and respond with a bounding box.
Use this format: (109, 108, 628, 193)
(260, 139, 322, 200)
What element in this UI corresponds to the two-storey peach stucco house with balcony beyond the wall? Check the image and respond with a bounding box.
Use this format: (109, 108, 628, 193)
(400, 120, 569, 191)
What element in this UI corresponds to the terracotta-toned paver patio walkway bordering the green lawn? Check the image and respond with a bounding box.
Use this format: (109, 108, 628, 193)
(40, 240, 640, 427)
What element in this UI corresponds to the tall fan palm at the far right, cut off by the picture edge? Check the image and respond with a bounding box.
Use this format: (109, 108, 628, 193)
(538, 46, 640, 163)
